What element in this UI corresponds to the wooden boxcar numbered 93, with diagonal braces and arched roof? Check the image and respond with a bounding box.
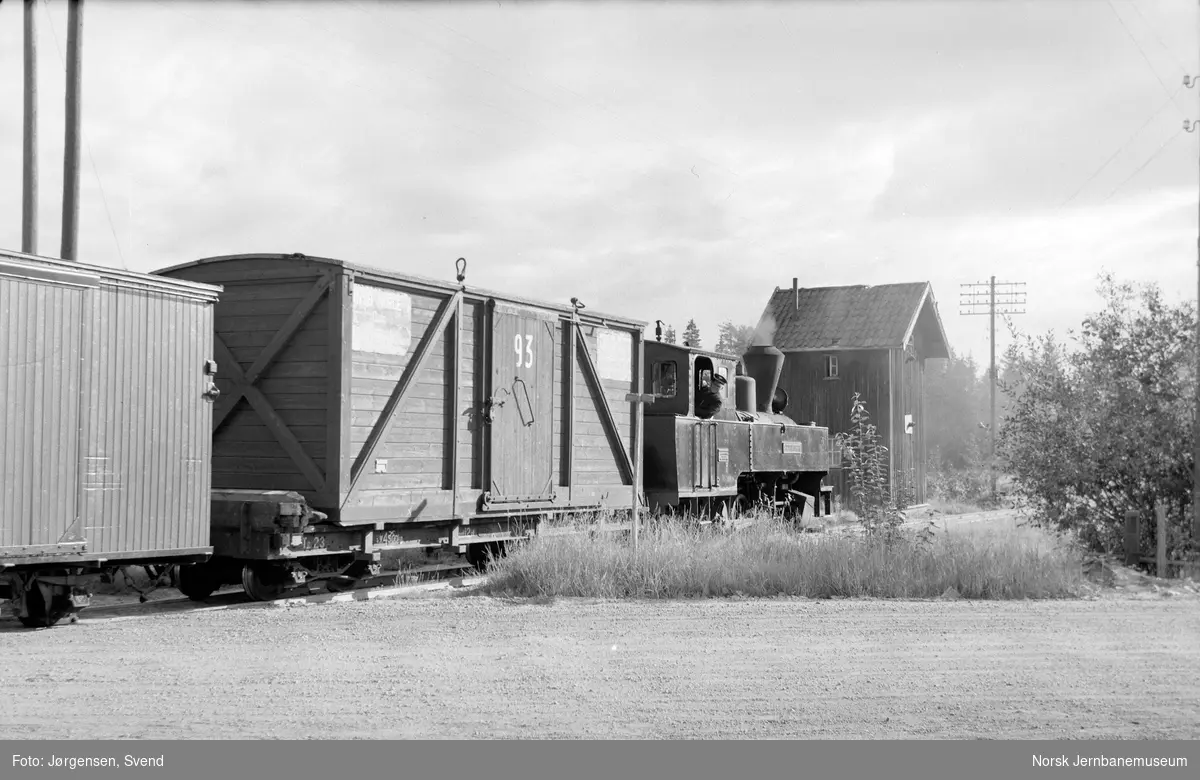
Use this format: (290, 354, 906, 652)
(160, 254, 644, 598)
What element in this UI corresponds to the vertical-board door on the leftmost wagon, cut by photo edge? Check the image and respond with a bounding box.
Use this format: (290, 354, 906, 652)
(0, 276, 89, 547)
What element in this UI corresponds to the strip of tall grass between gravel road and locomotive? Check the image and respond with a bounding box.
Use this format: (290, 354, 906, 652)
(484, 518, 1086, 599)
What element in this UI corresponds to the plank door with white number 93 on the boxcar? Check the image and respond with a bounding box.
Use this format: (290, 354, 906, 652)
(487, 301, 558, 503)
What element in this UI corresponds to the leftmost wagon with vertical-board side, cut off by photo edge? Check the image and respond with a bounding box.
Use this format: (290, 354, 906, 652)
(0, 252, 220, 625)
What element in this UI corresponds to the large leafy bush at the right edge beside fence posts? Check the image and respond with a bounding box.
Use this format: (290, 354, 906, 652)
(1000, 275, 1196, 553)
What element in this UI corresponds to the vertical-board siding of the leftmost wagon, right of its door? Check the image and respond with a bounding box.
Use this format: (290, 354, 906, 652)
(82, 284, 212, 553)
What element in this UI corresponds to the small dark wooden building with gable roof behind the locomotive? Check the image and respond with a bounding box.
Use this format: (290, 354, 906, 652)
(756, 278, 949, 504)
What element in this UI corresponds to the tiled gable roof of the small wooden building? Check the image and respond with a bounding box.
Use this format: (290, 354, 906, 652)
(760, 282, 946, 352)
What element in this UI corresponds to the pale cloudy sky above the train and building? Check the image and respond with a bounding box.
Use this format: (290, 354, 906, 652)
(0, 0, 1200, 360)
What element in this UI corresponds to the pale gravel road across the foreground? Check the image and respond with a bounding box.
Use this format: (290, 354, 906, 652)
(0, 594, 1200, 739)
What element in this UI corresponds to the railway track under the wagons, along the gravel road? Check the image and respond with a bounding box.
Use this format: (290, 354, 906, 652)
(0, 569, 487, 634)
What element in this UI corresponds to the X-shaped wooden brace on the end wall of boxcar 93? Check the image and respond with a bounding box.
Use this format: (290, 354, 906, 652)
(212, 274, 334, 493)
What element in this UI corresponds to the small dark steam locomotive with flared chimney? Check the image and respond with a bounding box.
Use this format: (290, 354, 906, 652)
(643, 342, 834, 517)
